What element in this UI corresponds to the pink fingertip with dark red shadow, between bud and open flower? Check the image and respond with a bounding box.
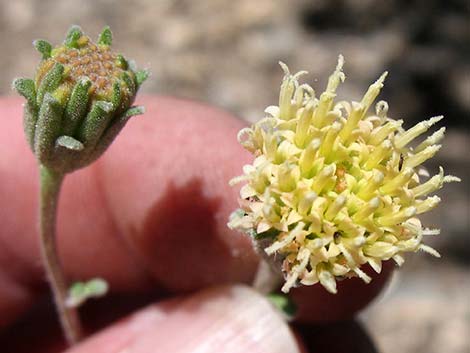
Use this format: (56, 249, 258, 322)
(97, 97, 257, 291)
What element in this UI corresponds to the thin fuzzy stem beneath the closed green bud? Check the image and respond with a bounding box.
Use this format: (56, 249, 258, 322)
(39, 165, 82, 345)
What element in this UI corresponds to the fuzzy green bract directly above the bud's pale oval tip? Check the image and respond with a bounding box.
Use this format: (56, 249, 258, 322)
(63, 77, 91, 135)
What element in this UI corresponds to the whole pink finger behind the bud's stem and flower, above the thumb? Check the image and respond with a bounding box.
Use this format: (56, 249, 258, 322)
(0, 97, 390, 328)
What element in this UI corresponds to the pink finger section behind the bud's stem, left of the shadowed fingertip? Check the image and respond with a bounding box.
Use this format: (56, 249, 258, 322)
(0, 98, 154, 327)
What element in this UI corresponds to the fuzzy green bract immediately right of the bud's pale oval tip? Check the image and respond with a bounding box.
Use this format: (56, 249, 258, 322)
(79, 101, 114, 147)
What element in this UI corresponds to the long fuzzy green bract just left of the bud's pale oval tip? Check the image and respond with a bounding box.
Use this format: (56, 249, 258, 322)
(34, 93, 64, 166)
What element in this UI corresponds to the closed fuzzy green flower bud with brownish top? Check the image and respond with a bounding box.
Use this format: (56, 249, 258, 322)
(13, 26, 149, 173)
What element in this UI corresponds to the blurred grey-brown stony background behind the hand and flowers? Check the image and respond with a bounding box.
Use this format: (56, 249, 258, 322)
(0, 0, 470, 353)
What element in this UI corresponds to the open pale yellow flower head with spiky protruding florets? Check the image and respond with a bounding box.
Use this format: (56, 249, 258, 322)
(229, 56, 459, 293)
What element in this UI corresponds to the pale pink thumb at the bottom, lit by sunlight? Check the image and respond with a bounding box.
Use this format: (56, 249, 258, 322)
(68, 285, 300, 353)
